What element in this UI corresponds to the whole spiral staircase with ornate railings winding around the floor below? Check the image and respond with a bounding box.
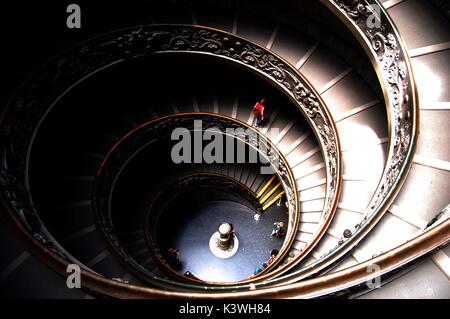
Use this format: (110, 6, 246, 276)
(0, 0, 450, 299)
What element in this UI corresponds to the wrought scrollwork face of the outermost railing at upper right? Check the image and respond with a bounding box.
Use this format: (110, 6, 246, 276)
(331, 0, 416, 211)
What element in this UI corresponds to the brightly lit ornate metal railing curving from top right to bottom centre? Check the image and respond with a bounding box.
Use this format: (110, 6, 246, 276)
(272, 0, 418, 283)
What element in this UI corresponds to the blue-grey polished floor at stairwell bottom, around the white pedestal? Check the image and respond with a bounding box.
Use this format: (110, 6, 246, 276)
(162, 201, 288, 282)
